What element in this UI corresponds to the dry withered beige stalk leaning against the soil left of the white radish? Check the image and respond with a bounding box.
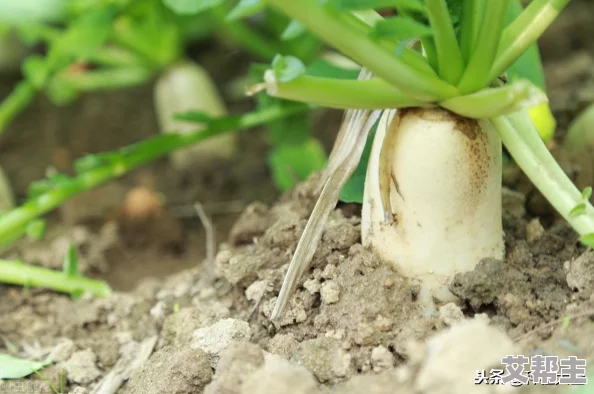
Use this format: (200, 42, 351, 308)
(270, 106, 381, 322)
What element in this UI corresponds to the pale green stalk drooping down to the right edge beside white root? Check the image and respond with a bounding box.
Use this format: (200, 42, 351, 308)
(491, 110, 594, 236)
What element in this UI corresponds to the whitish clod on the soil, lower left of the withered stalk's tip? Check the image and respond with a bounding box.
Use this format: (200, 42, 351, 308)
(190, 319, 251, 368)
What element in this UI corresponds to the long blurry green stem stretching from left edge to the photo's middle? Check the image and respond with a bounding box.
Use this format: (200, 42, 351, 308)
(0, 104, 309, 243)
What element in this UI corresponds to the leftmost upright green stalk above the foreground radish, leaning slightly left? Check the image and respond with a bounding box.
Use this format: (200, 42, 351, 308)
(425, 0, 464, 85)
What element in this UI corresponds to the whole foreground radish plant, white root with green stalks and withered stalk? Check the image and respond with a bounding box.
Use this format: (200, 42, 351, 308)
(244, 0, 594, 321)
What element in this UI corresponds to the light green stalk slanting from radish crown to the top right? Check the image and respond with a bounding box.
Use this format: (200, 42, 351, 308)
(489, 0, 569, 80)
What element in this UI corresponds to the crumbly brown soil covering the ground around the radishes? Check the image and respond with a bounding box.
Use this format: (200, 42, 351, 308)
(0, 1, 594, 394)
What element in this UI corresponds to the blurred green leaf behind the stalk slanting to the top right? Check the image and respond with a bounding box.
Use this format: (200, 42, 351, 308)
(505, 0, 546, 92)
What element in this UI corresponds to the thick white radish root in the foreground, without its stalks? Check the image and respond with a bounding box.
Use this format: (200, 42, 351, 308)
(361, 108, 504, 314)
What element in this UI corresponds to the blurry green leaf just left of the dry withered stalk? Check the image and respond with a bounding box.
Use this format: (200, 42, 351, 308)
(268, 138, 326, 191)
